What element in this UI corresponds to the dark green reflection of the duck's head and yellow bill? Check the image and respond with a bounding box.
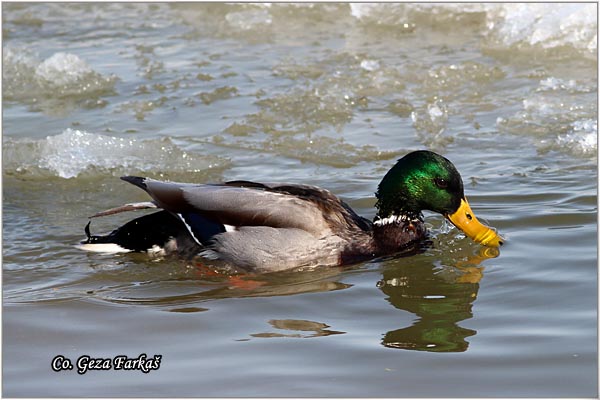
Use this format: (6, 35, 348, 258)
(377, 249, 498, 352)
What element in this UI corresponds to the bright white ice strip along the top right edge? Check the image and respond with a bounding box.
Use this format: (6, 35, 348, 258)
(350, 3, 598, 57)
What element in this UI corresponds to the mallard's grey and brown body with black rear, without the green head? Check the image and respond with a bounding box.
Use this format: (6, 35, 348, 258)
(85, 176, 425, 272)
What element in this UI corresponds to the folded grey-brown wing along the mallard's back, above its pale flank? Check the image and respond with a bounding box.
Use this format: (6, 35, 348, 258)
(121, 176, 370, 237)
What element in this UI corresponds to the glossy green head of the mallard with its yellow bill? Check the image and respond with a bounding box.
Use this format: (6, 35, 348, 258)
(376, 150, 503, 247)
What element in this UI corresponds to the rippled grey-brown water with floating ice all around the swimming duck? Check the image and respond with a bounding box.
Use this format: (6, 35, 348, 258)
(3, 3, 598, 397)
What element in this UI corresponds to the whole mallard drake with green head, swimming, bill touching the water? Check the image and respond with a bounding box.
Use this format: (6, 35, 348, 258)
(81, 151, 503, 272)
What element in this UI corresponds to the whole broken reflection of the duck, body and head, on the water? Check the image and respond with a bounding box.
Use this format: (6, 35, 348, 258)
(88, 244, 498, 352)
